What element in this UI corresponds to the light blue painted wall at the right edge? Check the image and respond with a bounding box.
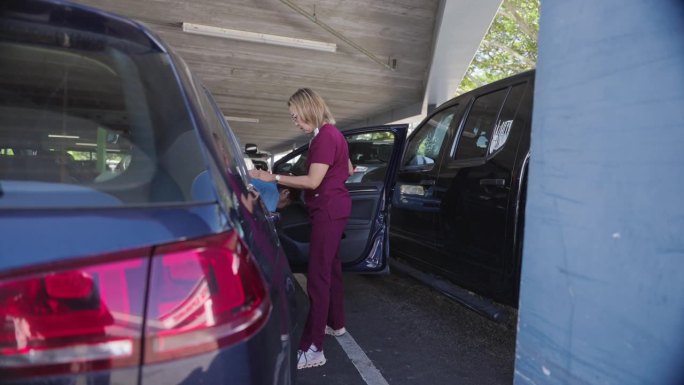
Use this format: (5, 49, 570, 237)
(515, 0, 684, 385)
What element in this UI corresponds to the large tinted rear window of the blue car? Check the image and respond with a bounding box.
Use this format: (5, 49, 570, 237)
(0, 20, 206, 207)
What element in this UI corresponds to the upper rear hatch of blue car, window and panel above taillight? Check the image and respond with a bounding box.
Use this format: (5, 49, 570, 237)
(0, 1, 220, 269)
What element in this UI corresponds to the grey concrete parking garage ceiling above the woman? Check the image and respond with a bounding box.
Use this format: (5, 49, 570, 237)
(76, 0, 501, 152)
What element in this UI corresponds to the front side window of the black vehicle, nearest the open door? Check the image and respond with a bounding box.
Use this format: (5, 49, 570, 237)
(404, 106, 457, 166)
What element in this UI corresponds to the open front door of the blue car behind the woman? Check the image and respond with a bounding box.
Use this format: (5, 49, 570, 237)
(273, 124, 408, 273)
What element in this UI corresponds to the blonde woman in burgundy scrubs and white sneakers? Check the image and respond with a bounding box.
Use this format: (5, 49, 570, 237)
(250, 88, 353, 369)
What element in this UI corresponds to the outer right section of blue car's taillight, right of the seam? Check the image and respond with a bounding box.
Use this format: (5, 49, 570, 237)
(144, 232, 271, 363)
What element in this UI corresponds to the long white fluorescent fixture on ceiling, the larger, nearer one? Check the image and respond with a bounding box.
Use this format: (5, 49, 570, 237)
(183, 23, 337, 52)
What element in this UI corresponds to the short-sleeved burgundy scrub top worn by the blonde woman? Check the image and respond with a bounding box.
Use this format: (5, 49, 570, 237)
(304, 123, 351, 220)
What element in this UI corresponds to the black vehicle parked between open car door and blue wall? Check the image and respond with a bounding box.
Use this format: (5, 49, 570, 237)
(390, 71, 534, 307)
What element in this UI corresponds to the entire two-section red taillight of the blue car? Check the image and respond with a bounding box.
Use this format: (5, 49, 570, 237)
(0, 228, 270, 379)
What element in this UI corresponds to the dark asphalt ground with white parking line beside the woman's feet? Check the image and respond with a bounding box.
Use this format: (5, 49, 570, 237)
(297, 273, 517, 385)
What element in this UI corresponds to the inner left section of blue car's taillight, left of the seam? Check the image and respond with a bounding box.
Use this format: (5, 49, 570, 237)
(0, 254, 149, 378)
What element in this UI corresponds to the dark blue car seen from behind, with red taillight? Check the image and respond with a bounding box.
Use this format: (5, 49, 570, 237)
(0, 0, 307, 385)
